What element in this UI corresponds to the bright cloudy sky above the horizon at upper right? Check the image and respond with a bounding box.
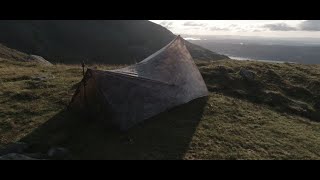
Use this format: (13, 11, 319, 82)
(150, 20, 320, 38)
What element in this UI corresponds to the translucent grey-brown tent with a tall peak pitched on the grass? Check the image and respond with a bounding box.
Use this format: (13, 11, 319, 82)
(69, 36, 208, 130)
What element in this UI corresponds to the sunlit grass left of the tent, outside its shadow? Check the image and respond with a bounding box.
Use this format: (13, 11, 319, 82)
(0, 59, 122, 144)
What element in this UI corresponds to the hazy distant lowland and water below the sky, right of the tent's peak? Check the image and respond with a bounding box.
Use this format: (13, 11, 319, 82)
(189, 38, 320, 64)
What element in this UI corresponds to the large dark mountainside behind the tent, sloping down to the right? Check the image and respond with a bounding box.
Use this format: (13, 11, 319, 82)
(0, 20, 228, 64)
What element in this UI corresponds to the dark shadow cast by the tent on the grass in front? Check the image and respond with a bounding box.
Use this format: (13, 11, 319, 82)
(21, 97, 207, 159)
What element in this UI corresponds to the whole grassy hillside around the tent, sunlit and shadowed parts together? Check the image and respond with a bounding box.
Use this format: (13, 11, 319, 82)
(0, 59, 320, 159)
